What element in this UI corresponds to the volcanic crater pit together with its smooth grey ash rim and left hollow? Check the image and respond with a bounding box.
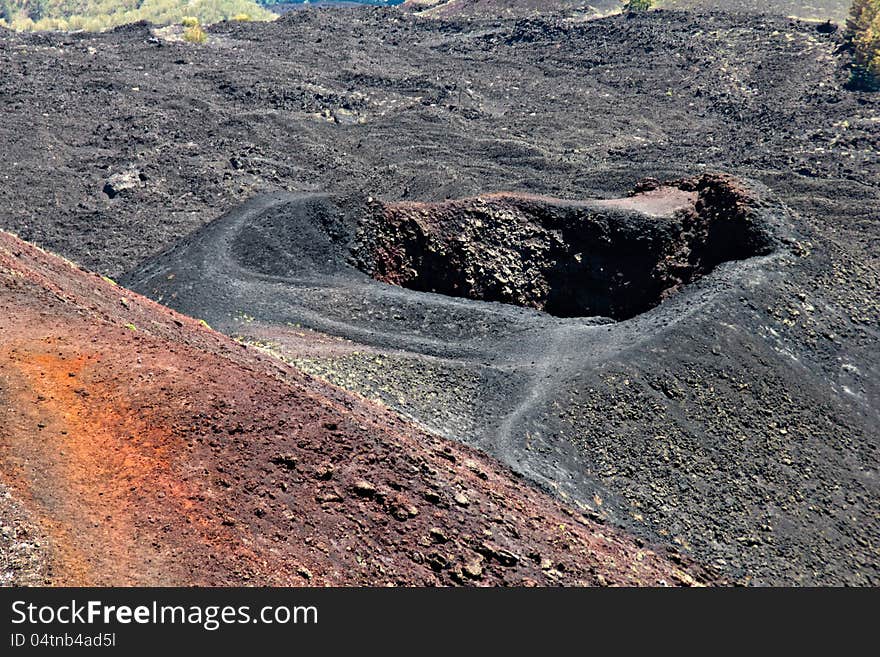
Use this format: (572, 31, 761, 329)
(123, 174, 787, 353)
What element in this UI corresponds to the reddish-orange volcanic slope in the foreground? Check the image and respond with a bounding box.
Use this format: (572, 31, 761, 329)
(0, 233, 706, 585)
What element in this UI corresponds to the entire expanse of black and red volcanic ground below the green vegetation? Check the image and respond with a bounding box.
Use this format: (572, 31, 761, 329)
(0, 3, 880, 585)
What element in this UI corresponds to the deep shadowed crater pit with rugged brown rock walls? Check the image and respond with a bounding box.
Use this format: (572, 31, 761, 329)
(355, 175, 773, 319)
